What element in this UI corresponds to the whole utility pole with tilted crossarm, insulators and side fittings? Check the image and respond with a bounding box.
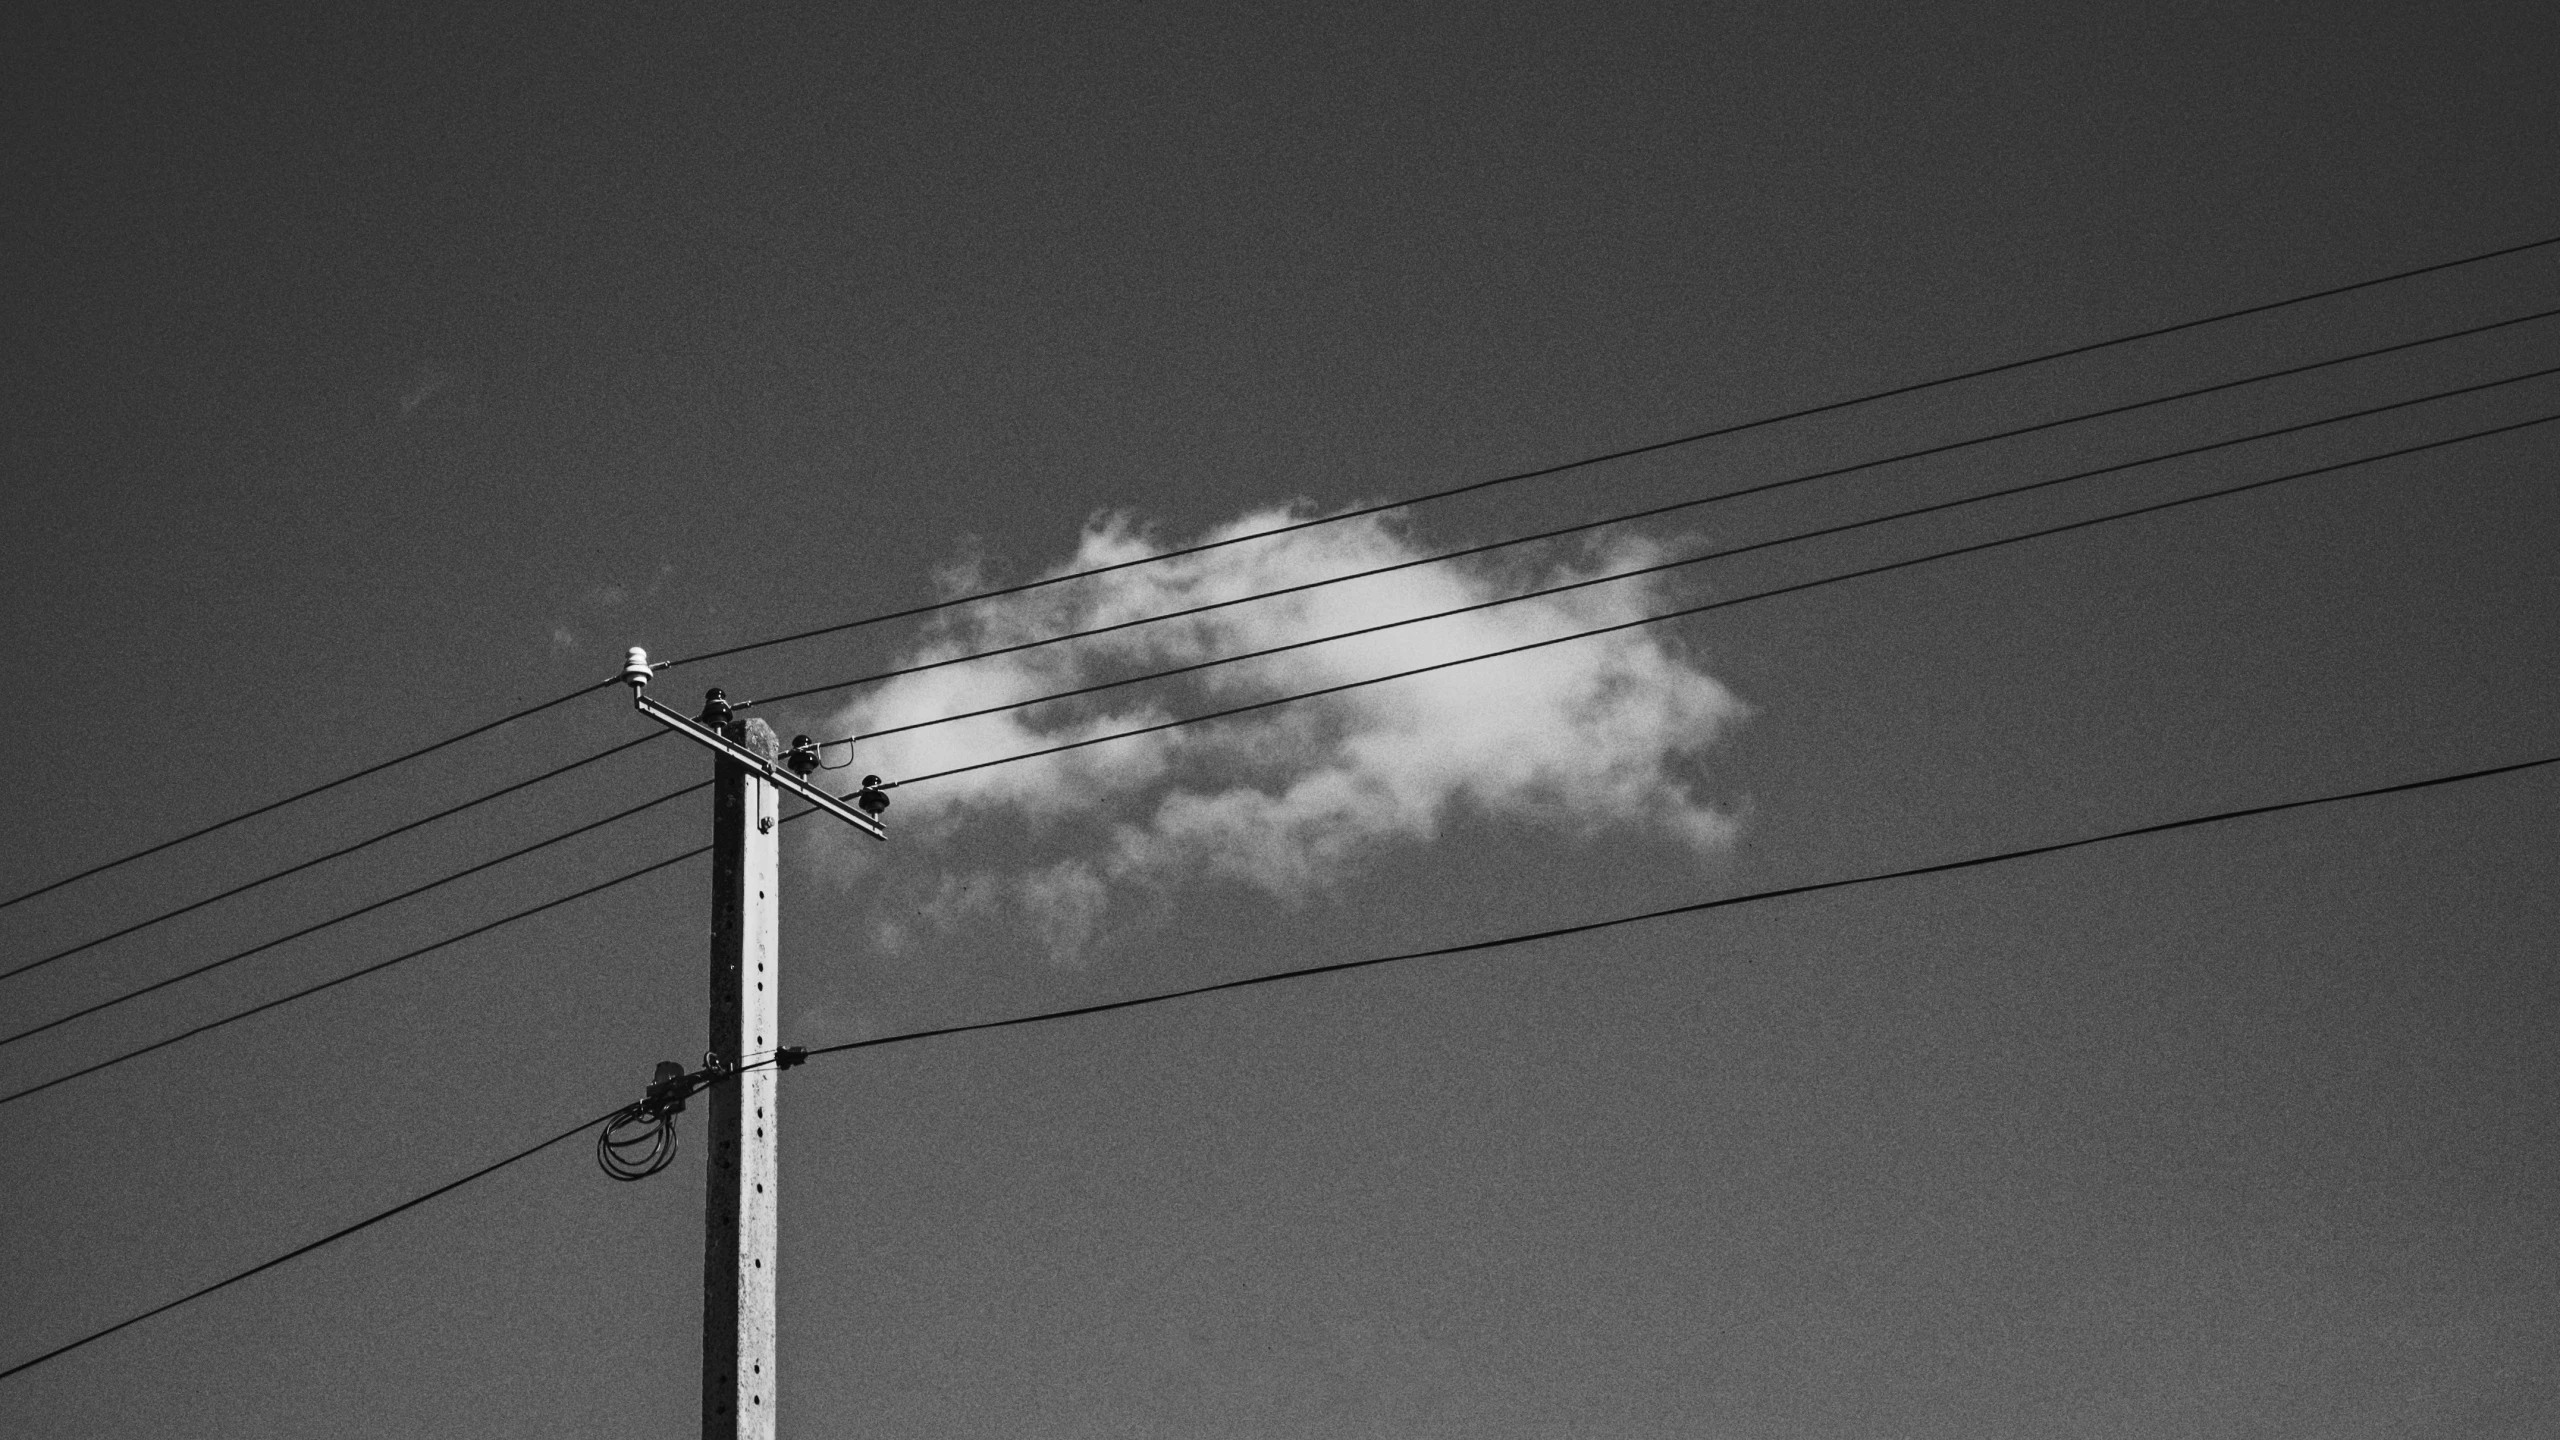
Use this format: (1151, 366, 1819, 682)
(622, 648, 888, 1440)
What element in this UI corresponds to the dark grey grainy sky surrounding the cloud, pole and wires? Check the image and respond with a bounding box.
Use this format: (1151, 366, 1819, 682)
(0, 5, 2560, 1440)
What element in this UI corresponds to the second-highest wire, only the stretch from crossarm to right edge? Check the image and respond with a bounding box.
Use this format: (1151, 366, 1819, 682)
(758, 307, 2560, 707)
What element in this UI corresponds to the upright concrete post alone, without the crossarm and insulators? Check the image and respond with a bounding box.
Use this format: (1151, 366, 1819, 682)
(701, 720, 781, 1440)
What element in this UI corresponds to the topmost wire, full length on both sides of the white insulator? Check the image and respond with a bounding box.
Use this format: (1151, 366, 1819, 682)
(0, 236, 2560, 910)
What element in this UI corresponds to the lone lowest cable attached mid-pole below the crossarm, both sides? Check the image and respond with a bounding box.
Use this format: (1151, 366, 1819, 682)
(0, 737, 2560, 1381)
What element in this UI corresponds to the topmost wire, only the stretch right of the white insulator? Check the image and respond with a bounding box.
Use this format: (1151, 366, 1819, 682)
(658, 236, 2560, 671)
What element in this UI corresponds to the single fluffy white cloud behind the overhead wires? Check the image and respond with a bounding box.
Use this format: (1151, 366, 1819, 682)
(835, 499, 1741, 958)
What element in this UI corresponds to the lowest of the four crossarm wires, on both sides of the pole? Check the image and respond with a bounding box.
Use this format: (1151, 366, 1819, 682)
(0, 397, 2560, 1104)
